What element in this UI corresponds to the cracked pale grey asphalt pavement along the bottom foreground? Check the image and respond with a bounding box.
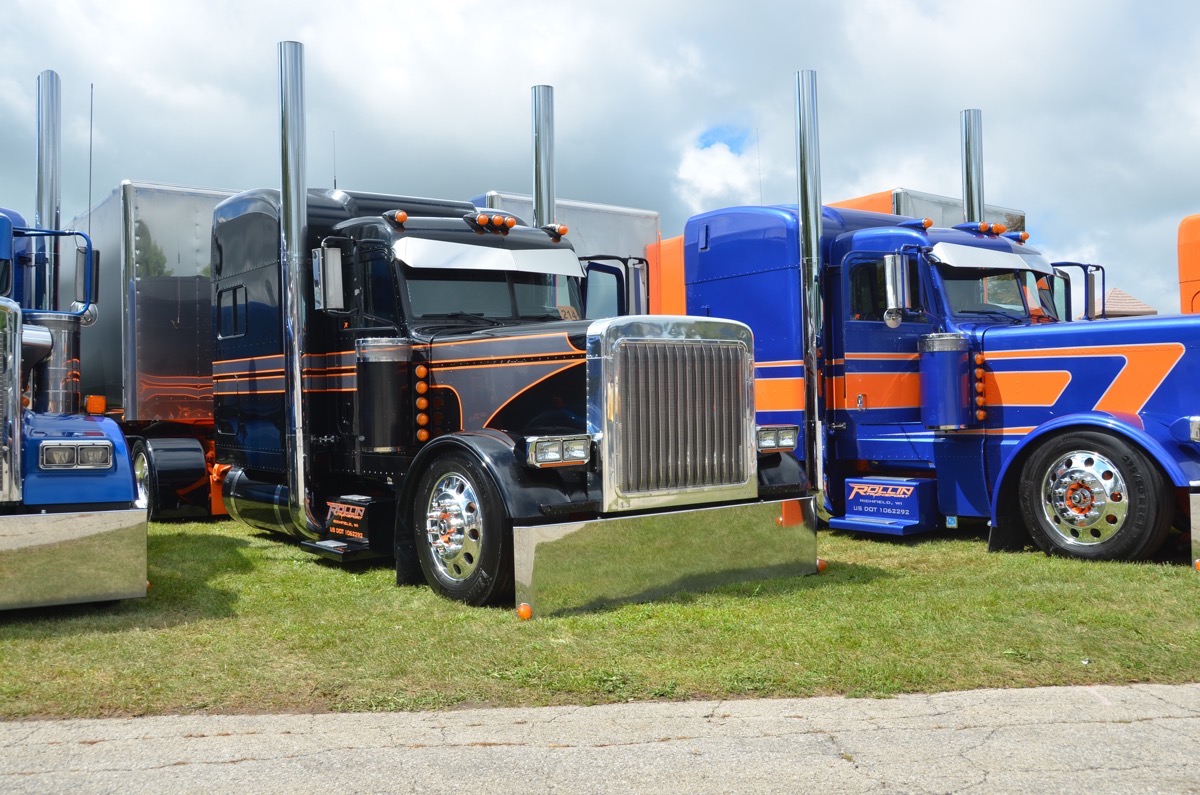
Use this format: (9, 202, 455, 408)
(0, 683, 1200, 795)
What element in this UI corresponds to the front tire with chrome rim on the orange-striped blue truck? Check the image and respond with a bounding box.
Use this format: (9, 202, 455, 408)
(1020, 431, 1174, 561)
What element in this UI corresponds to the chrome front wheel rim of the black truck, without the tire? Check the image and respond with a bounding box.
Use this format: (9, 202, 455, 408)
(425, 472, 484, 582)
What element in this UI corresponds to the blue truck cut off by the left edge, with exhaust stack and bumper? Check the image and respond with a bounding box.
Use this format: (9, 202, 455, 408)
(0, 72, 146, 610)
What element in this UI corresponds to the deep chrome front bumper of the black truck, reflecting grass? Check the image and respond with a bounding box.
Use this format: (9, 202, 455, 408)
(512, 497, 817, 616)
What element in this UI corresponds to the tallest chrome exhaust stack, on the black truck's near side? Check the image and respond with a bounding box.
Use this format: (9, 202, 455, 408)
(280, 41, 322, 538)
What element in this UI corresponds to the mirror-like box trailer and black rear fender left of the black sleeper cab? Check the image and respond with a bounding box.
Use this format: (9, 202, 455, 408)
(72, 180, 233, 519)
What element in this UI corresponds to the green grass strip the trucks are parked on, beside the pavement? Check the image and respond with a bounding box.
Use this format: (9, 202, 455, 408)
(0, 521, 1200, 718)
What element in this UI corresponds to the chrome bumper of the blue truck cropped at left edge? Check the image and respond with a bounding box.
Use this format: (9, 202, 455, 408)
(0, 509, 146, 610)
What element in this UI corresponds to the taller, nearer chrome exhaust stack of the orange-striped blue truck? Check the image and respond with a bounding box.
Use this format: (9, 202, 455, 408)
(796, 70, 824, 507)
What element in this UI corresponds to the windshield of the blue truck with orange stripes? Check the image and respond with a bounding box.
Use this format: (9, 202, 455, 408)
(938, 265, 1060, 322)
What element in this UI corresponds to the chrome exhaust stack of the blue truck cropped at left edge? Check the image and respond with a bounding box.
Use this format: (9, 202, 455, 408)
(31, 70, 62, 310)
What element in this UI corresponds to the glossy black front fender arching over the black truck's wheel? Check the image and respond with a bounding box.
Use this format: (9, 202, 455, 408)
(400, 429, 586, 521)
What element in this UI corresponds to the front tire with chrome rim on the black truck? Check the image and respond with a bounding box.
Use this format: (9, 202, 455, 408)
(413, 453, 512, 606)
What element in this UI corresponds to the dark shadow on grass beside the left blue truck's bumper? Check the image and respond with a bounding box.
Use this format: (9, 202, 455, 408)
(0, 528, 254, 636)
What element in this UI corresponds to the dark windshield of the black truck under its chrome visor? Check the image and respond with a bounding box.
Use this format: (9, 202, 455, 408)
(402, 268, 583, 324)
